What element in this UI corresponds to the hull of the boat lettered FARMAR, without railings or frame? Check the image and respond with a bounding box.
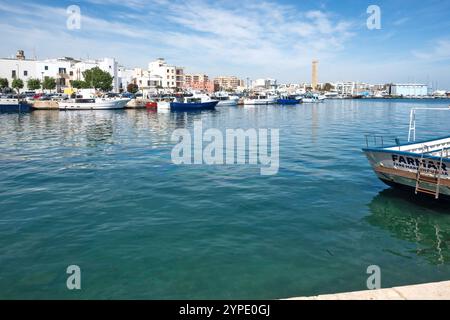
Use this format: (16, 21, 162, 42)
(363, 149, 450, 197)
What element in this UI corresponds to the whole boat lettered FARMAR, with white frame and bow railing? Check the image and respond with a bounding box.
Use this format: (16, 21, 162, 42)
(363, 107, 450, 199)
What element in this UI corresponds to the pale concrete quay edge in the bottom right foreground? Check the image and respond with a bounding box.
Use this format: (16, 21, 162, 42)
(288, 281, 450, 300)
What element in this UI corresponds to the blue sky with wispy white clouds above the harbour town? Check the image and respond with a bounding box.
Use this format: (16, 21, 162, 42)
(0, 0, 450, 89)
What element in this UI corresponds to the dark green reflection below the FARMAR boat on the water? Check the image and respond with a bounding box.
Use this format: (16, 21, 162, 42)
(366, 189, 450, 265)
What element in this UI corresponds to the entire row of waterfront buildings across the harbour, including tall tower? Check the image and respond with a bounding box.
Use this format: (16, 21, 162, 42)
(0, 50, 450, 97)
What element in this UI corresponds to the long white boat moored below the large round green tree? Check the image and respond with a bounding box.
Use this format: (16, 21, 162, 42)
(59, 98, 130, 110)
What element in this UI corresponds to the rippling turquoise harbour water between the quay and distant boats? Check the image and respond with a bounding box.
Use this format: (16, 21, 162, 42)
(0, 100, 450, 299)
